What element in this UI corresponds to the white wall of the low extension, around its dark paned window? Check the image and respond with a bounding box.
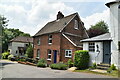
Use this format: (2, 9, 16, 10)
(83, 42, 103, 66)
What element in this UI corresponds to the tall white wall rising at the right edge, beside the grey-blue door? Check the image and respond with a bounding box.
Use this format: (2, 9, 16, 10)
(110, 3, 120, 66)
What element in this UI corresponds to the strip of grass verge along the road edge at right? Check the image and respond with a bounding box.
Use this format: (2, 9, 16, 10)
(73, 69, 120, 77)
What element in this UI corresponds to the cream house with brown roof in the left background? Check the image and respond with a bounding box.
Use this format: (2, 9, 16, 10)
(8, 36, 33, 56)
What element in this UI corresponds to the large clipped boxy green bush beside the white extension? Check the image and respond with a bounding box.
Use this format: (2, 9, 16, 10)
(74, 50, 89, 69)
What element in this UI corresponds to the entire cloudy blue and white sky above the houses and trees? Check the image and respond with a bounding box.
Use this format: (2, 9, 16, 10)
(0, 0, 112, 36)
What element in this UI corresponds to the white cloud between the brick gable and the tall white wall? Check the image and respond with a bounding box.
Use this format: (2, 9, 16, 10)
(81, 9, 109, 29)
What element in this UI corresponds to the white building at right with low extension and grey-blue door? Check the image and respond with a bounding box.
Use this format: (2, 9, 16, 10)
(82, 0, 120, 67)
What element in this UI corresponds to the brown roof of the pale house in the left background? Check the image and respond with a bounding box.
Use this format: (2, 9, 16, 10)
(10, 36, 33, 43)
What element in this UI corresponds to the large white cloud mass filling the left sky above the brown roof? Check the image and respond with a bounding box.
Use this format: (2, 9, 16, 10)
(0, 0, 74, 35)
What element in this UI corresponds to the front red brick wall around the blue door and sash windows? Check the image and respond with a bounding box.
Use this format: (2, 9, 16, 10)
(34, 33, 61, 63)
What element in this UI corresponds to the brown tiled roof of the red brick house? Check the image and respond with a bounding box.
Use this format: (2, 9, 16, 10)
(34, 13, 77, 36)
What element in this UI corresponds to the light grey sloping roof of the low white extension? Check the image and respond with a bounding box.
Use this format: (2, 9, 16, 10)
(81, 33, 112, 42)
